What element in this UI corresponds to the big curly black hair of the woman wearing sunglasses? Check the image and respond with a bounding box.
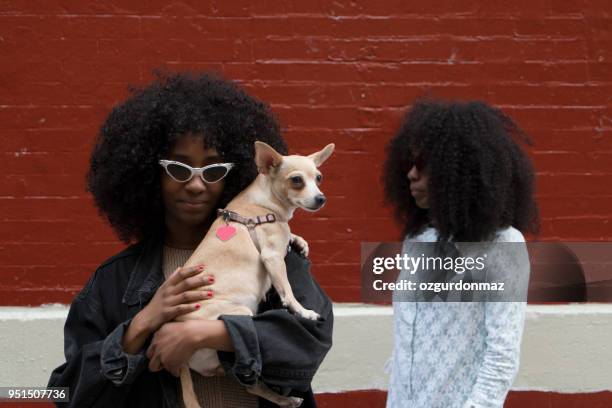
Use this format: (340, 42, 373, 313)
(86, 71, 287, 243)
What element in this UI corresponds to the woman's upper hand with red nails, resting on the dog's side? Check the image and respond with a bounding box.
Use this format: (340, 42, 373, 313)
(135, 265, 214, 333)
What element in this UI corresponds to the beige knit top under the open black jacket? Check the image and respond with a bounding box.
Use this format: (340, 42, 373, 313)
(163, 245, 259, 408)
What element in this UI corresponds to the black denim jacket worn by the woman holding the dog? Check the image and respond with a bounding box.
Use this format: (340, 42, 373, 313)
(48, 233, 333, 408)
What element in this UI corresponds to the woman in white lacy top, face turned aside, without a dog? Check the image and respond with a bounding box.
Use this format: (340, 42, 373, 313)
(383, 100, 538, 408)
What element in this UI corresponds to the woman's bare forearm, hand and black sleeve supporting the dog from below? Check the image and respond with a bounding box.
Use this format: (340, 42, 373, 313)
(147, 247, 333, 391)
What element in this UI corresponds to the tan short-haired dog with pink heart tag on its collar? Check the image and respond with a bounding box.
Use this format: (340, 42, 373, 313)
(176, 142, 334, 408)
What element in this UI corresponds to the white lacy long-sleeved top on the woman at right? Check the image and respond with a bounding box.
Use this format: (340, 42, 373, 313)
(387, 227, 529, 408)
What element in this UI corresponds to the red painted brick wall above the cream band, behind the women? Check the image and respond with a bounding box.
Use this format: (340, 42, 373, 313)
(0, 0, 612, 305)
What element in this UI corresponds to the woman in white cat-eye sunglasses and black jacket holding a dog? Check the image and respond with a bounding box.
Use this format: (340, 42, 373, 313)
(49, 73, 333, 408)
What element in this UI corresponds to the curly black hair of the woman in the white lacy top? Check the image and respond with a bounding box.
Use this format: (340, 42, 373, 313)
(383, 99, 539, 242)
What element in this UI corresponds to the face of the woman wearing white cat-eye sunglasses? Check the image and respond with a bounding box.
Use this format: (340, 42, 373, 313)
(161, 134, 225, 228)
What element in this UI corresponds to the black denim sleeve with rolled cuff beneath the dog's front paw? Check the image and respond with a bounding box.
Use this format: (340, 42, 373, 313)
(218, 251, 333, 391)
